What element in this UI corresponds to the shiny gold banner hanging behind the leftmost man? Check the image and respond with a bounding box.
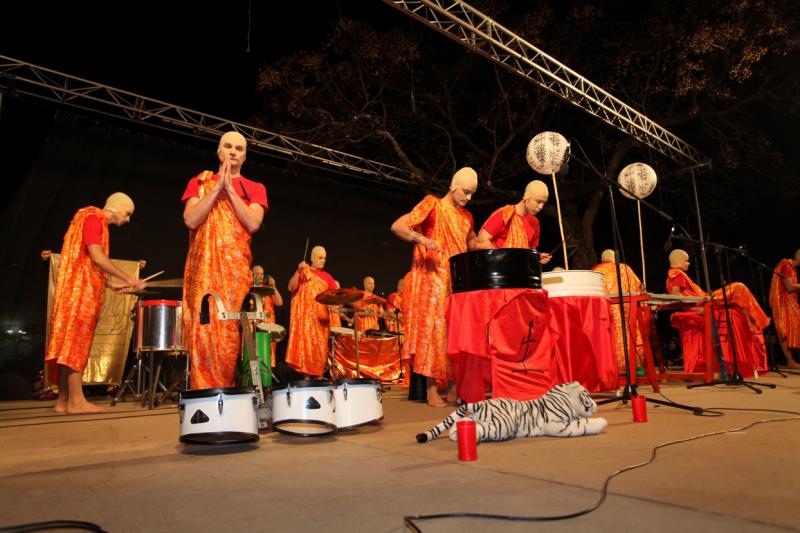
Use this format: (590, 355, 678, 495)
(45, 253, 139, 385)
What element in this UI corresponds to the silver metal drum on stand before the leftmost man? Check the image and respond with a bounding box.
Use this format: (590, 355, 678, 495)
(134, 300, 186, 352)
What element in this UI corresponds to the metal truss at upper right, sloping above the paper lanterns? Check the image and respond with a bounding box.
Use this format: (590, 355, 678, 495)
(384, 0, 708, 165)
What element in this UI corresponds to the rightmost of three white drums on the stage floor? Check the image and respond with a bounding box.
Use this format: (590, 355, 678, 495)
(333, 379, 383, 431)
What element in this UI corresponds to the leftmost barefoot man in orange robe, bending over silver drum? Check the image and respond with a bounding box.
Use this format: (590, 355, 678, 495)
(44, 192, 146, 414)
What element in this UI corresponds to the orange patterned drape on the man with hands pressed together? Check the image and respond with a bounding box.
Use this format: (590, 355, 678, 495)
(183, 171, 253, 389)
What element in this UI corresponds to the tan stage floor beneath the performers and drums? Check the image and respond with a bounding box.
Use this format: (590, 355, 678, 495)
(0, 375, 800, 533)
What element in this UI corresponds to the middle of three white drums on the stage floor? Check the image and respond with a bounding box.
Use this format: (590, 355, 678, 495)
(272, 379, 336, 437)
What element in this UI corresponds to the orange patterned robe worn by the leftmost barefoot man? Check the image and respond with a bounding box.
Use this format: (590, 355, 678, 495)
(44, 206, 109, 380)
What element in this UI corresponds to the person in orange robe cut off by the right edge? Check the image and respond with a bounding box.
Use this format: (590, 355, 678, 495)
(769, 250, 800, 368)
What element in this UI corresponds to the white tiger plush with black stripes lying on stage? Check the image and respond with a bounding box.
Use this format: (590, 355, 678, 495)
(417, 381, 608, 443)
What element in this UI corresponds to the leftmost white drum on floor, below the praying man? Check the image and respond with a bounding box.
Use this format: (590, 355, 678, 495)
(178, 387, 258, 444)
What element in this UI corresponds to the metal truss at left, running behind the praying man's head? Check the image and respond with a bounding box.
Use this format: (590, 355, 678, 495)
(0, 55, 418, 188)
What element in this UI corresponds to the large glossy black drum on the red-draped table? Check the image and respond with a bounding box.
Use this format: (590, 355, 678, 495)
(450, 248, 542, 293)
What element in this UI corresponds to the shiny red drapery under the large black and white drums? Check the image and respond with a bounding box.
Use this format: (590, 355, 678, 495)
(446, 289, 618, 402)
